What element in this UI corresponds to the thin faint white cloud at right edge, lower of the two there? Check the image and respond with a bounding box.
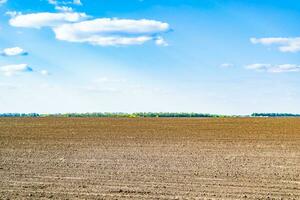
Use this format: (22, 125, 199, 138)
(245, 64, 300, 73)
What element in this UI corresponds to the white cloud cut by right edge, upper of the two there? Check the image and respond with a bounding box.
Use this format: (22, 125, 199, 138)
(250, 37, 300, 52)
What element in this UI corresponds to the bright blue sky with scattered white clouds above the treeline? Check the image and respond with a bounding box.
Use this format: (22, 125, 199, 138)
(0, 0, 300, 114)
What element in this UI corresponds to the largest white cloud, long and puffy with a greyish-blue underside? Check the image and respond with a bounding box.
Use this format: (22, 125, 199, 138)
(53, 18, 169, 46)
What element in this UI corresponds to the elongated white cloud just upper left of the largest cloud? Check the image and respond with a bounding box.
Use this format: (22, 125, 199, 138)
(9, 12, 87, 28)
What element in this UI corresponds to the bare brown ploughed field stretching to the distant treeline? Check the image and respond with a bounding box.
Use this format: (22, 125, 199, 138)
(0, 118, 300, 199)
